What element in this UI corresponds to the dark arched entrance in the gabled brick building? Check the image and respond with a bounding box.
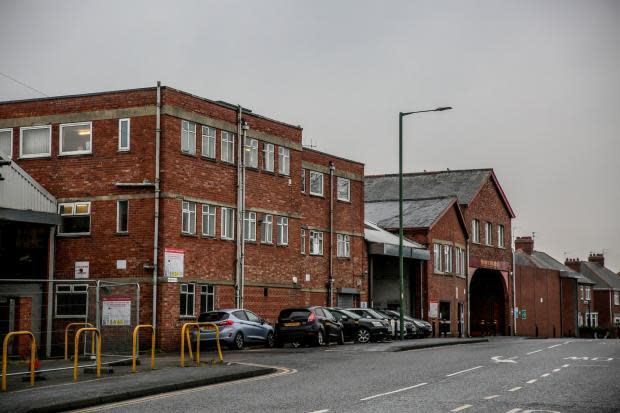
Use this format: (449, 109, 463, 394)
(469, 268, 508, 336)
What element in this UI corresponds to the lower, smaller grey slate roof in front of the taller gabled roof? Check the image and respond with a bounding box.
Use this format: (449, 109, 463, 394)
(364, 197, 456, 228)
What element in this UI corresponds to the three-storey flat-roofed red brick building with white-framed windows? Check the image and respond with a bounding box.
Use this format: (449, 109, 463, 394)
(0, 87, 366, 348)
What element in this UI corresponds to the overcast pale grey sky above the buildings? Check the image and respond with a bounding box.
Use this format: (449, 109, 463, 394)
(0, 0, 620, 271)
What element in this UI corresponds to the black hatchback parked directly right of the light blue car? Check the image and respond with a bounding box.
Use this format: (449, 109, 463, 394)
(275, 307, 344, 347)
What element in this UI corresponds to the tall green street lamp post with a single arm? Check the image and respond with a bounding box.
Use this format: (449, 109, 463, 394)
(398, 106, 452, 340)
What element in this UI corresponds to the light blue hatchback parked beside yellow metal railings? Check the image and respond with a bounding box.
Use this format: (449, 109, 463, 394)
(192, 308, 273, 350)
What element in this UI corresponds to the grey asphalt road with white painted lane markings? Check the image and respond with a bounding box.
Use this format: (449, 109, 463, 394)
(76, 337, 620, 413)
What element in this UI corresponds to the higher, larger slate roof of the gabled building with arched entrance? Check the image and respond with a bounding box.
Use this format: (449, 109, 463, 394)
(364, 168, 515, 218)
